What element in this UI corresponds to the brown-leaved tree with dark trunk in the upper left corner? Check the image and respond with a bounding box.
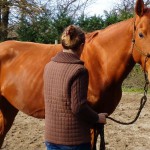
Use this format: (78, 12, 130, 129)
(0, 0, 44, 41)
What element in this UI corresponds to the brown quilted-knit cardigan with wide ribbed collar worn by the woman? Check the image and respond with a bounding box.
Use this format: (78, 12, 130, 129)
(44, 52, 98, 145)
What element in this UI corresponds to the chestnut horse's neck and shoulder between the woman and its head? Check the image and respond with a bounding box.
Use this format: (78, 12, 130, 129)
(83, 19, 135, 96)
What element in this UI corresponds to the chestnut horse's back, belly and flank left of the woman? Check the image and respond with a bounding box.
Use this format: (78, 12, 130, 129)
(0, 41, 61, 117)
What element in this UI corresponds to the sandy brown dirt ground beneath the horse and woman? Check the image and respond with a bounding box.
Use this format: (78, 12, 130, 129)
(2, 93, 150, 150)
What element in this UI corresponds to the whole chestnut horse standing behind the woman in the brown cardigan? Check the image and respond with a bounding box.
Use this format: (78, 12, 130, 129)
(0, 0, 150, 146)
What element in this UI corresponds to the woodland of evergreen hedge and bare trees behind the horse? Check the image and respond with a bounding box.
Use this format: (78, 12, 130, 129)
(0, 0, 150, 43)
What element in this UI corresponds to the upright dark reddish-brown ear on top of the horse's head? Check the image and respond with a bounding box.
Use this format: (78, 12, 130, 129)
(135, 0, 144, 17)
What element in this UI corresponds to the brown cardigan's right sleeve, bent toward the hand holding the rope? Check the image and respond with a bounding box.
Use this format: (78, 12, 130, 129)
(71, 69, 99, 124)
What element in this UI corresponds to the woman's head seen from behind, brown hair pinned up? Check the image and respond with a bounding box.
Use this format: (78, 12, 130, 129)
(61, 25, 85, 51)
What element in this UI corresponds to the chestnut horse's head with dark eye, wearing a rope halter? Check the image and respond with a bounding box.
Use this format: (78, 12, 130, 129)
(133, 0, 150, 80)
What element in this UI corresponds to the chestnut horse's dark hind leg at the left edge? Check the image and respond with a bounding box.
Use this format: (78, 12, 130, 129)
(0, 97, 18, 148)
